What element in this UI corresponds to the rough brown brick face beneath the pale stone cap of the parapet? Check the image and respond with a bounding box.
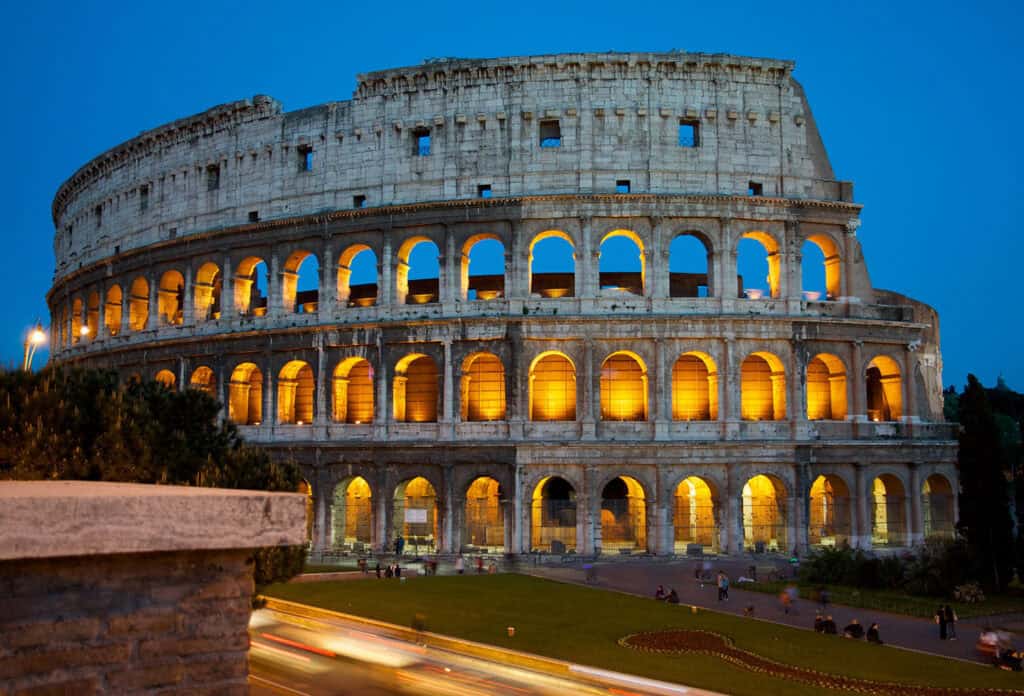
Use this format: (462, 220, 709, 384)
(0, 550, 253, 696)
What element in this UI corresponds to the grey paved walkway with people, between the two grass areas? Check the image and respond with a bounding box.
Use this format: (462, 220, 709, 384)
(519, 559, 1020, 662)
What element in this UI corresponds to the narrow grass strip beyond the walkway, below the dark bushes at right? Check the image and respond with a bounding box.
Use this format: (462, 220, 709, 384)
(735, 580, 1024, 618)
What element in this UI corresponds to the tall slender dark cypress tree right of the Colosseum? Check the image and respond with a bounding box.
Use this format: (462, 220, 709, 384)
(958, 375, 1015, 591)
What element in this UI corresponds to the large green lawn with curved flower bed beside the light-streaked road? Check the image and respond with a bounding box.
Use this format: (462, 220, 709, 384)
(266, 574, 1024, 696)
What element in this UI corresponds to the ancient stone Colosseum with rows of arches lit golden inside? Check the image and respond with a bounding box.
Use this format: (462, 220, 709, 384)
(48, 52, 958, 557)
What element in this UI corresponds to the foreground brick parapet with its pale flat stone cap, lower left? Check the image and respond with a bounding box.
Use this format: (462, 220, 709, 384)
(0, 481, 305, 696)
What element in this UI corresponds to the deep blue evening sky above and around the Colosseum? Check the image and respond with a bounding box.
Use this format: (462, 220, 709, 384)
(0, 0, 1024, 390)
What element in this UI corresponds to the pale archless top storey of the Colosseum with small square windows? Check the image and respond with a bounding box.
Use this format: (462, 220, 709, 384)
(53, 52, 852, 278)
